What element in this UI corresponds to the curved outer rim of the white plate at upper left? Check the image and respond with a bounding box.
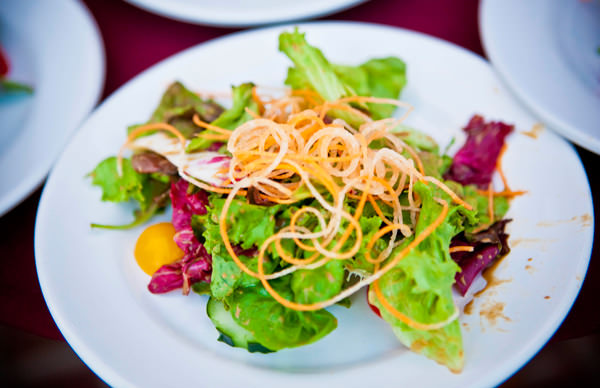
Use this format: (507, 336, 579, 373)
(0, 0, 106, 217)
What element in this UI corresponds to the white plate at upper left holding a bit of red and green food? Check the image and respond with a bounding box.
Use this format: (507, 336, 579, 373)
(0, 0, 104, 216)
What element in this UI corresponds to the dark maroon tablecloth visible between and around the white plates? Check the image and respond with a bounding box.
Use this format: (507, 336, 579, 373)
(0, 0, 600, 384)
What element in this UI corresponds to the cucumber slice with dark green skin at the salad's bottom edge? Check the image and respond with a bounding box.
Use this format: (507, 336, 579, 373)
(206, 298, 273, 353)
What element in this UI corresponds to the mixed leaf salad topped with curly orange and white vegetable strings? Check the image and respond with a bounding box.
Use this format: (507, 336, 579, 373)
(91, 31, 520, 371)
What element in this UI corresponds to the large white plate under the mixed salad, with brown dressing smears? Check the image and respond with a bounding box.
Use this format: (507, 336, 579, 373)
(35, 23, 593, 388)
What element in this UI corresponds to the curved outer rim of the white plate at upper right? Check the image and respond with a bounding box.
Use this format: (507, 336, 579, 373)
(477, 0, 600, 154)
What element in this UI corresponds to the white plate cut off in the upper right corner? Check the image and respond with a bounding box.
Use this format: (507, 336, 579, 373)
(479, 0, 600, 154)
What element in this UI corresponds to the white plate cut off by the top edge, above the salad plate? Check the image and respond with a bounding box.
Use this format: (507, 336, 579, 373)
(127, 0, 366, 27)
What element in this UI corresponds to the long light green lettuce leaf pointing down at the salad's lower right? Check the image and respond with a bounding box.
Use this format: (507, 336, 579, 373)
(369, 182, 475, 371)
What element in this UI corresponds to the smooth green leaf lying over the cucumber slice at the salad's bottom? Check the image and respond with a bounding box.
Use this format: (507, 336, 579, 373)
(226, 276, 337, 351)
